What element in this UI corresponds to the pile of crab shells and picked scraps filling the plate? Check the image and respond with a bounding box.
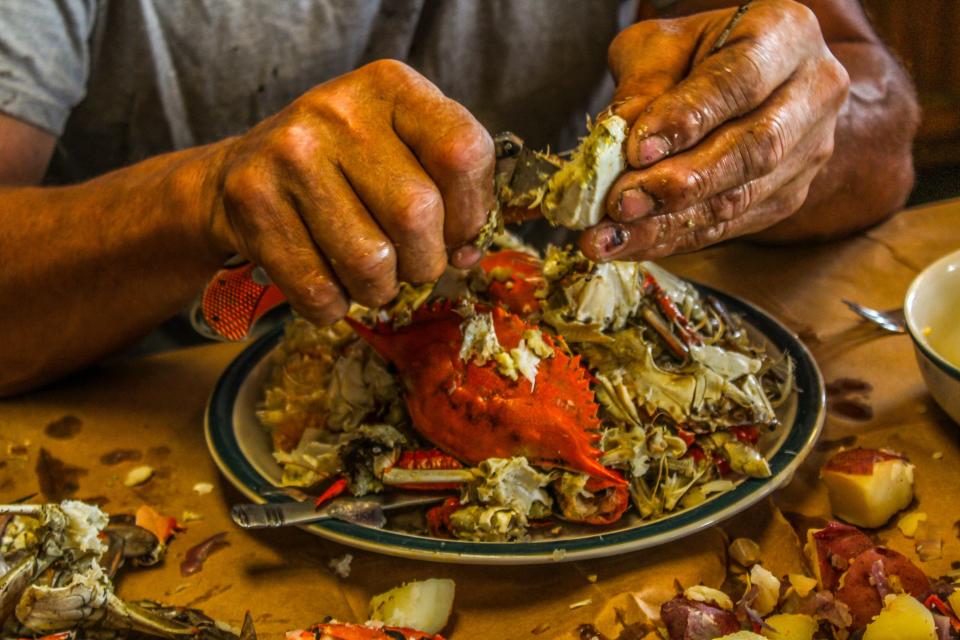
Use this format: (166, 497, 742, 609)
(257, 239, 793, 541)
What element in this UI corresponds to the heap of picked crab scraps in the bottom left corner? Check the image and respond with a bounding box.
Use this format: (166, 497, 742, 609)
(0, 500, 236, 640)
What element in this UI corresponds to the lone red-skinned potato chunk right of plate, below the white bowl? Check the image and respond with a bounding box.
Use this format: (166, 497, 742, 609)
(820, 449, 913, 528)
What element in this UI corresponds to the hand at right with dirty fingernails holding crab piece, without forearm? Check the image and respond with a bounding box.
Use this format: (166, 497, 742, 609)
(580, 0, 849, 260)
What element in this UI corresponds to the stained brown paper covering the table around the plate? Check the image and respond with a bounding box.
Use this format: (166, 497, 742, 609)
(0, 200, 960, 639)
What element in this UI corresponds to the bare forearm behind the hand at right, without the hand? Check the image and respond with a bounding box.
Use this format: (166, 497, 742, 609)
(756, 42, 919, 242)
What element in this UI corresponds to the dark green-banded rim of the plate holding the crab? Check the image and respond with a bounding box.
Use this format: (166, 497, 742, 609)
(205, 285, 825, 564)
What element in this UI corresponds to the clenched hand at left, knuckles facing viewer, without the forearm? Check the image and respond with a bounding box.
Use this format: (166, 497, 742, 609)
(210, 61, 495, 323)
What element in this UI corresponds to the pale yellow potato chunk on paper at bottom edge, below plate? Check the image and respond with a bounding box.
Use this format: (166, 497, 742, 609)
(370, 578, 456, 634)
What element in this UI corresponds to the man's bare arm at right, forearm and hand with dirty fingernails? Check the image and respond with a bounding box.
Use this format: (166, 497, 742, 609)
(581, 0, 918, 259)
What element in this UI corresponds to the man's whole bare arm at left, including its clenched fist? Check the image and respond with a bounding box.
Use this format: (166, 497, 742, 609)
(0, 61, 494, 395)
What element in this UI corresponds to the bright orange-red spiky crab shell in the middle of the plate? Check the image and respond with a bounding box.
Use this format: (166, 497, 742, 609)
(351, 304, 626, 489)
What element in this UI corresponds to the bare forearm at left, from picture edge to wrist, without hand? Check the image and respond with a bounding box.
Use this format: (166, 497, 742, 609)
(0, 145, 223, 395)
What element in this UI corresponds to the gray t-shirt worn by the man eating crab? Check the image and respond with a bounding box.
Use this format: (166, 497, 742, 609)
(0, 0, 636, 183)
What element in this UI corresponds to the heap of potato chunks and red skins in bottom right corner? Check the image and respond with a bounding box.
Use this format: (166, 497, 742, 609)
(600, 521, 960, 640)
